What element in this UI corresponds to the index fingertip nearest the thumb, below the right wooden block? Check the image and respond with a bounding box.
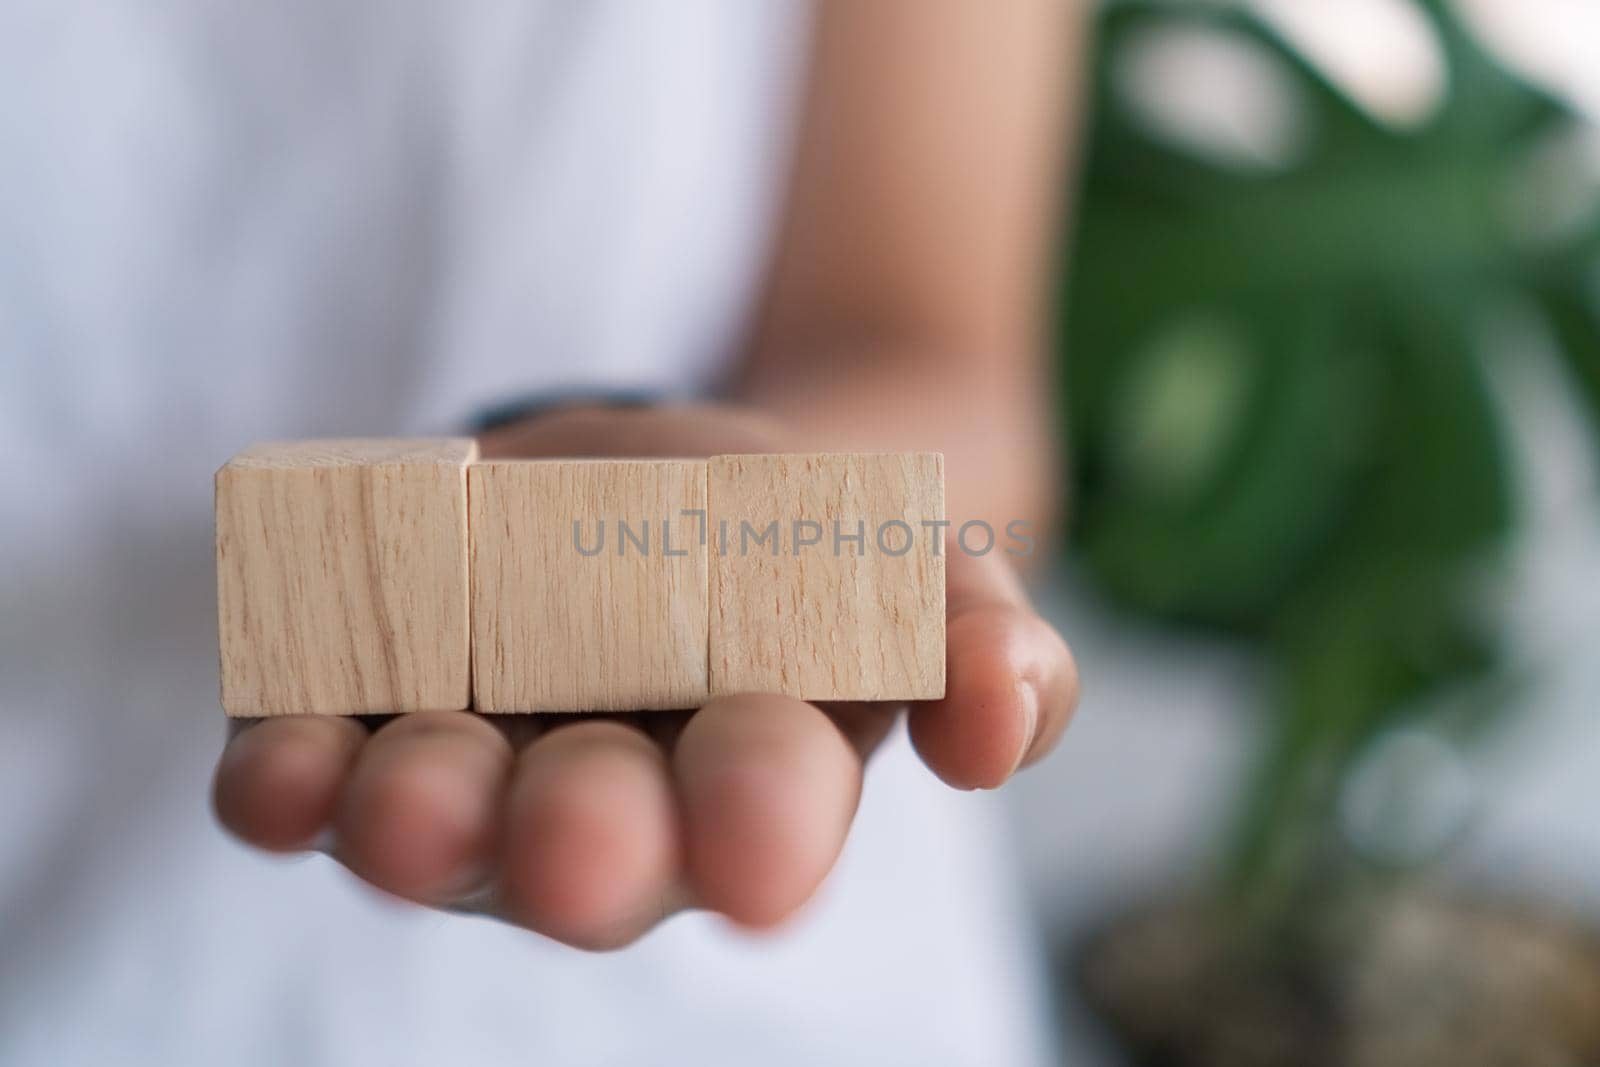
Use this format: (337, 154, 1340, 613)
(674, 694, 861, 926)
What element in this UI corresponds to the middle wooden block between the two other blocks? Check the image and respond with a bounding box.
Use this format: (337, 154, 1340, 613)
(470, 459, 709, 712)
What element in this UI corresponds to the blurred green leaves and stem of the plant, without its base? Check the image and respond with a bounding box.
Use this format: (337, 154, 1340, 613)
(1059, 0, 1600, 915)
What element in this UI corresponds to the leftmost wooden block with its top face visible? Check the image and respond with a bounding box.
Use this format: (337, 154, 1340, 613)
(216, 438, 477, 715)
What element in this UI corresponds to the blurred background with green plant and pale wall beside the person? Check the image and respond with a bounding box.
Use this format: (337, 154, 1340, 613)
(1008, 0, 1600, 1065)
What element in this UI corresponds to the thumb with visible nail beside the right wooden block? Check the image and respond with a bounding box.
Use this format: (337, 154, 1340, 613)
(910, 553, 1078, 789)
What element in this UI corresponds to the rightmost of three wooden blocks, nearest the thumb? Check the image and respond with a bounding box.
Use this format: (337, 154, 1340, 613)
(707, 453, 944, 701)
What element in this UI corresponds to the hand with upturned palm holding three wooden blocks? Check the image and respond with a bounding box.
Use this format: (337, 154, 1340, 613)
(214, 408, 1077, 949)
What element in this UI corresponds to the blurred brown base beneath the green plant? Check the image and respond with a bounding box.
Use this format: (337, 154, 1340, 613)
(1075, 894, 1600, 1067)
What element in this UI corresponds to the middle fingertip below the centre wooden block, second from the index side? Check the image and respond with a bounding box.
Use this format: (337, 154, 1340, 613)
(501, 720, 683, 949)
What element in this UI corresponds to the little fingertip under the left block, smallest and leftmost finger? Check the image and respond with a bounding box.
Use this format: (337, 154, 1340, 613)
(211, 715, 366, 851)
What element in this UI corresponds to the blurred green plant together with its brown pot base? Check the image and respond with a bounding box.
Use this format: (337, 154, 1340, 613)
(1061, 0, 1600, 1067)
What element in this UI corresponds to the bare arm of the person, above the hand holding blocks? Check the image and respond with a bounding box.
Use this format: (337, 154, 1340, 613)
(731, 0, 1086, 547)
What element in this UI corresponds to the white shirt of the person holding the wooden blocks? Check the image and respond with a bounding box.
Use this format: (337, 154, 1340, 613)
(0, 0, 1046, 1067)
